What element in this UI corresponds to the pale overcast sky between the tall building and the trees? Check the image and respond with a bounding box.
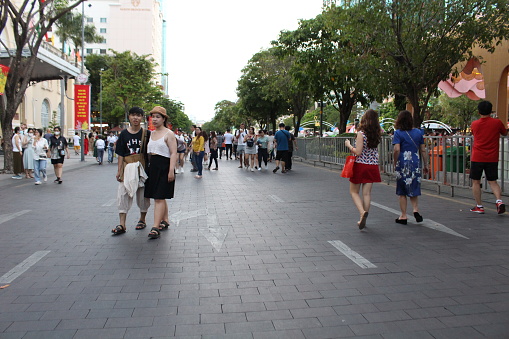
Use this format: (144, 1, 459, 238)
(163, 0, 323, 121)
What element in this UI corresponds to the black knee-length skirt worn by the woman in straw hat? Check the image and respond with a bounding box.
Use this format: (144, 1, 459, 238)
(145, 154, 175, 199)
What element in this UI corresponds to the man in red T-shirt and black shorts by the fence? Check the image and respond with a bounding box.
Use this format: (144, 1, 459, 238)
(470, 101, 507, 214)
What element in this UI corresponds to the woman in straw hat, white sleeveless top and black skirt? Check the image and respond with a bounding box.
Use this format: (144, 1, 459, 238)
(145, 106, 177, 239)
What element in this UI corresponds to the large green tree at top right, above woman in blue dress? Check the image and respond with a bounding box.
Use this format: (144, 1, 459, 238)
(340, 0, 509, 126)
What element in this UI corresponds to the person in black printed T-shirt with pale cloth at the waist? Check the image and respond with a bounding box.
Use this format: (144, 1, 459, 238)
(111, 106, 150, 235)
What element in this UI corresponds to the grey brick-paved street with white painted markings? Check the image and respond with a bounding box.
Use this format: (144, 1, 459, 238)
(0, 157, 509, 339)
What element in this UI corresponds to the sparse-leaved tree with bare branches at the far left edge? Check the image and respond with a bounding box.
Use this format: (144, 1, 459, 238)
(0, 0, 84, 173)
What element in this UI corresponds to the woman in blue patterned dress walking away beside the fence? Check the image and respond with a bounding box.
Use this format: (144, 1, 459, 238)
(392, 111, 428, 225)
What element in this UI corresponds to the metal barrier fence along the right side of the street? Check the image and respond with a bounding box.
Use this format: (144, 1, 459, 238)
(293, 136, 509, 193)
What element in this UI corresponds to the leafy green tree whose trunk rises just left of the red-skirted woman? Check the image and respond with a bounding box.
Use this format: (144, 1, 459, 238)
(273, 7, 377, 133)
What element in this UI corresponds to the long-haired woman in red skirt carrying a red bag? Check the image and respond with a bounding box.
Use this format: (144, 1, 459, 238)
(345, 109, 382, 230)
